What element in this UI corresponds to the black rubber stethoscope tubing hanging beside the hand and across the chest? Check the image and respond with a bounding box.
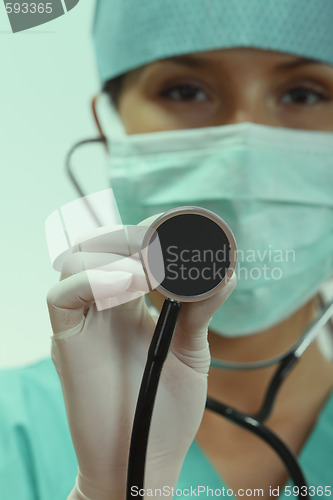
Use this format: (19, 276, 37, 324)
(126, 299, 333, 500)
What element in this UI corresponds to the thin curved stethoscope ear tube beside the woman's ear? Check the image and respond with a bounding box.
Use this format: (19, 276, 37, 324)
(65, 94, 108, 227)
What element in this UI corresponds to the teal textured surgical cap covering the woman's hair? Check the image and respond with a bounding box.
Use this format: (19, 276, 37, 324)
(93, 0, 333, 83)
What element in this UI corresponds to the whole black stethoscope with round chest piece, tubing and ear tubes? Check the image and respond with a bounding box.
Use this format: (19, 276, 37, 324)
(66, 113, 333, 500)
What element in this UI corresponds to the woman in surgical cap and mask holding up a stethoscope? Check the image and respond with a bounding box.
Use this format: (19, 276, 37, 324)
(48, 0, 333, 500)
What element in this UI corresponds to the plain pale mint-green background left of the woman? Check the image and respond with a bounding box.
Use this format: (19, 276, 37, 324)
(0, 0, 107, 368)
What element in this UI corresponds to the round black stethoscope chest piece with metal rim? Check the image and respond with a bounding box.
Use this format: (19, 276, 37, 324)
(142, 207, 237, 302)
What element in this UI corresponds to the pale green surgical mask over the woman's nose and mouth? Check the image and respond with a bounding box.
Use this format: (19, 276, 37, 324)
(104, 103, 333, 337)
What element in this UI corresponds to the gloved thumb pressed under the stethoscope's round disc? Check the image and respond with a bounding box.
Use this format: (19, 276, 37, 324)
(171, 273, 237, 371)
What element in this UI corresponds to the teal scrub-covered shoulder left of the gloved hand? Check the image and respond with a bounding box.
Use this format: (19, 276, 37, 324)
(0, 358, 77, 500)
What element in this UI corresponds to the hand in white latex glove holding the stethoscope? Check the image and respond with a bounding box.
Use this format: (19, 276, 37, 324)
(48, 219, 236, 500)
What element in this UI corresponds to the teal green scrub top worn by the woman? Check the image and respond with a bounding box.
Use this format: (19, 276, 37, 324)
(0, 359, 333, 500)
